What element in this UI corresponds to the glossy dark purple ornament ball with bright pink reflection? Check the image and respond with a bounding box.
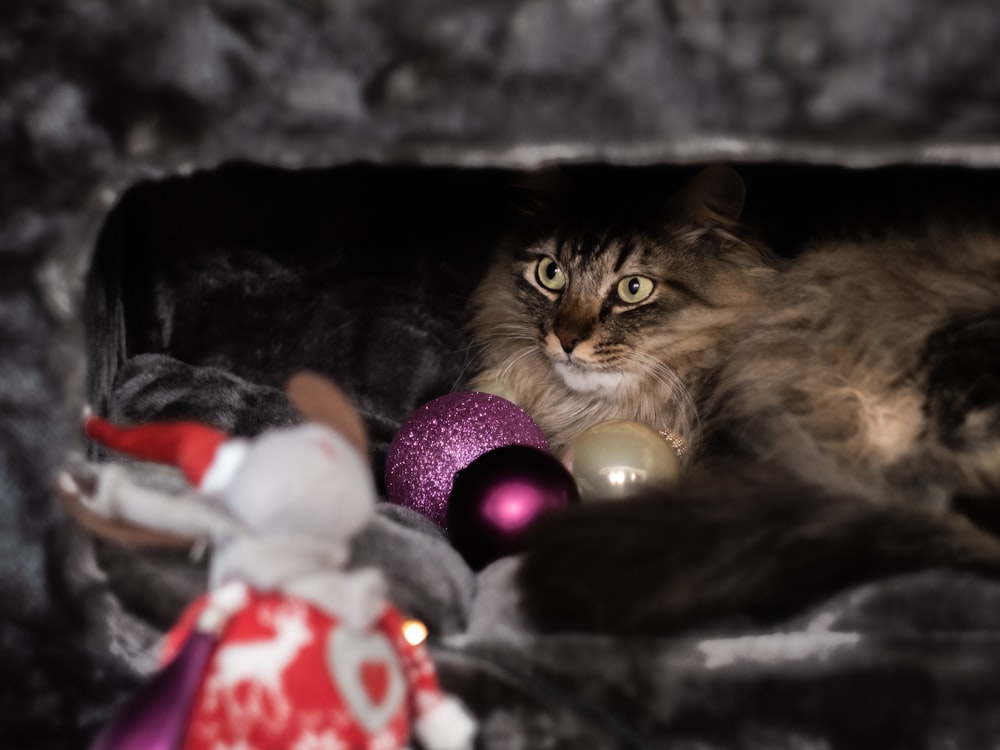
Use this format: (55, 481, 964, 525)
(448, 445, 580, 570)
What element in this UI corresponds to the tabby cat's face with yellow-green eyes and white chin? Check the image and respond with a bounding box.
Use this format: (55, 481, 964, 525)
(473, 165, 772, 394)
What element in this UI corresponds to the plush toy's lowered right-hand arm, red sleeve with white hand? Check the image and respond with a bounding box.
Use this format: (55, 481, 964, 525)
(379, 605, 476, 750)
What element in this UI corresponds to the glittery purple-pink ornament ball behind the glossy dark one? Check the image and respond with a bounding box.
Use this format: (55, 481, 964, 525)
(385, 391, 549, 531)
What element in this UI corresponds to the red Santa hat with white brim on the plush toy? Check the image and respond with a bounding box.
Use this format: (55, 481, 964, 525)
(83, 416, 246, 493)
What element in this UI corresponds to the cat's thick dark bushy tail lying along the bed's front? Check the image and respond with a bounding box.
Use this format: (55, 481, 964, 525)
(518, 472, 1000, 634)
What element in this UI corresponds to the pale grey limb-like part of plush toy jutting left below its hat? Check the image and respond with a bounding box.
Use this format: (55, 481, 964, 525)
(82, 464, 245, 539)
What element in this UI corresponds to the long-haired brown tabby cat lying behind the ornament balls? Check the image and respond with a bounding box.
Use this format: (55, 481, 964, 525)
(470, 167, 1000, 632)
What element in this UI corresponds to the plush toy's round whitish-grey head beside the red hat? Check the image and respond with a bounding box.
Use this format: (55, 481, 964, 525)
(223, 424, 376, 541)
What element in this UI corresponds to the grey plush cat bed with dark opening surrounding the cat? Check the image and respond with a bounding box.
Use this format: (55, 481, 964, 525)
(0, 0, 1000, 749)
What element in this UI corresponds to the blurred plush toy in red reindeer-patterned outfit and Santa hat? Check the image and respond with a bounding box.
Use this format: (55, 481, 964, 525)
(64, 374, 474, 750)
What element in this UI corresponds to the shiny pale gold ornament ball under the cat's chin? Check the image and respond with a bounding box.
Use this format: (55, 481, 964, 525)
(563, 420, 680, 502)
